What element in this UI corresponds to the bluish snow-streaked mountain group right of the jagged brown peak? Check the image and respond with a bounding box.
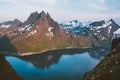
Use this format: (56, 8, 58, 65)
(61, 19, 120, 47)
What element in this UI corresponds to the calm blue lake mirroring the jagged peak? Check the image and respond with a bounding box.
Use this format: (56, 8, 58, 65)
(6, 48, 109, 80)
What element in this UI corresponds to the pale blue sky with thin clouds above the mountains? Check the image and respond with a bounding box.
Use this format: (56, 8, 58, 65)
(0, 0, 120, 22)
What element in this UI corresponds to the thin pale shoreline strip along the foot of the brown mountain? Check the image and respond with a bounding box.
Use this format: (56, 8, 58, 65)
(0, 47, 109, 57)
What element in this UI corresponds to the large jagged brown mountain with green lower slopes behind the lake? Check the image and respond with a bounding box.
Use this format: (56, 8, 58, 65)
(12, 11, 91, 52)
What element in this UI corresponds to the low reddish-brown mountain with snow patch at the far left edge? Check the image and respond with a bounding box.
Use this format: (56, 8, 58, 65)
(0, 19, 23, 40)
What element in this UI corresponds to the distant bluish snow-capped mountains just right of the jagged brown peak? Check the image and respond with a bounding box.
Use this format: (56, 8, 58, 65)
(60, 20, 91, 36)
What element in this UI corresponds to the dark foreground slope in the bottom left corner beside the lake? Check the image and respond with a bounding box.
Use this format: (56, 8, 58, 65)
(0, 54, 23, 80)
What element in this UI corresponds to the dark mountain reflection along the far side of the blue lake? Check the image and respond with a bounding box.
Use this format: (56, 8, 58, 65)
(21, 48, 108, 69)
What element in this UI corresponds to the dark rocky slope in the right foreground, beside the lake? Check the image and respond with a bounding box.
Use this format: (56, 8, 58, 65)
(84, 38, 120, 80)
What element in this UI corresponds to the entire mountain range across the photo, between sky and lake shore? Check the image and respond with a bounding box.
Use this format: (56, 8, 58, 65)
(0, 11, 120, 53)
